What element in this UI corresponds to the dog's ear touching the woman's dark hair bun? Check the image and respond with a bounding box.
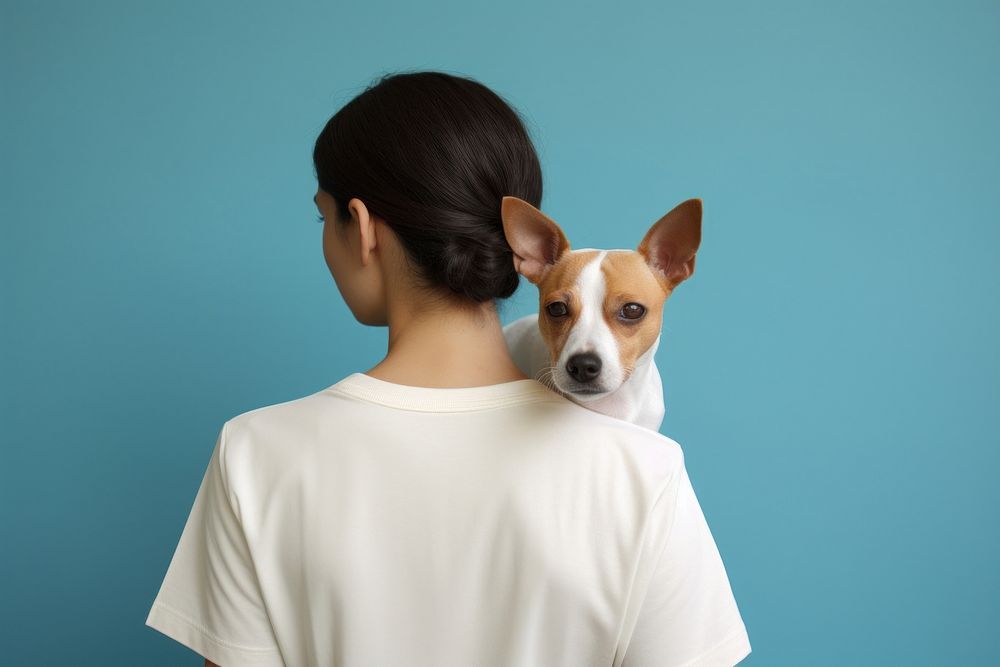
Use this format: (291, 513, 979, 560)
(500, 196, 569, 285)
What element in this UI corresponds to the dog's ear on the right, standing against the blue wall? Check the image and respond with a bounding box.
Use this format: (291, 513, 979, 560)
(638, 198, 701, 292)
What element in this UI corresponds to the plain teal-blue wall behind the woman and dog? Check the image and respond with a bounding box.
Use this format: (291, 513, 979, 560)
(0, 0, 1000, 665)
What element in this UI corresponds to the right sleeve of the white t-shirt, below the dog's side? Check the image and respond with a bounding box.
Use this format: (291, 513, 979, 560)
(622, 465, 750, 667)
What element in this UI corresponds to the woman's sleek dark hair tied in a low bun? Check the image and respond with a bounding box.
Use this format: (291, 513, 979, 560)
(313, 71, 542, 302)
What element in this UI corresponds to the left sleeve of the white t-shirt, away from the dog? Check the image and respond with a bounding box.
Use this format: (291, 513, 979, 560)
(146, 422, 284, 667)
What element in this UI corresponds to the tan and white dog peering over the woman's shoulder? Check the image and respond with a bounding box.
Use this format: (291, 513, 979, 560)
(501, 196, 702, 431)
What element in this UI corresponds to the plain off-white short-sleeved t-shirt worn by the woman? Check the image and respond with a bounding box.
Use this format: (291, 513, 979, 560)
(146, 373, 750, 667)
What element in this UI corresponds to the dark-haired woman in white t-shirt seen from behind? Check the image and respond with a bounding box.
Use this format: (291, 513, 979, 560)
(146, 72, 750, 667)
